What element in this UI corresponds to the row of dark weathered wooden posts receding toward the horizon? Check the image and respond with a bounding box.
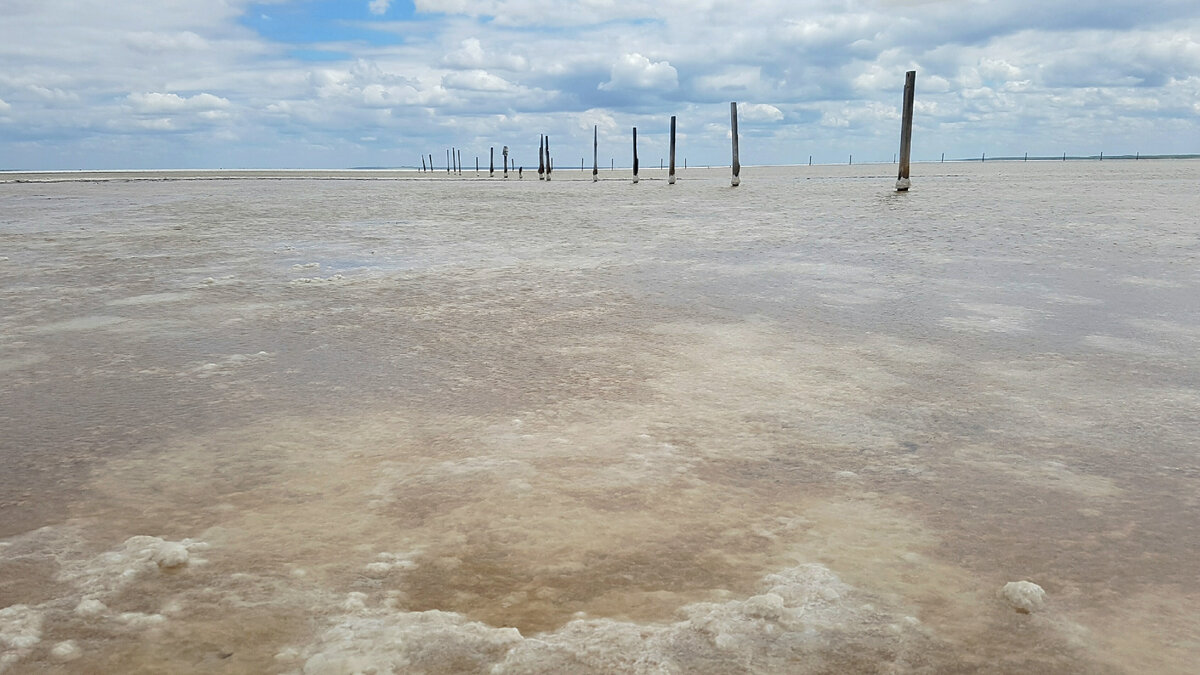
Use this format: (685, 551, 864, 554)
(412, 71, 916, 192)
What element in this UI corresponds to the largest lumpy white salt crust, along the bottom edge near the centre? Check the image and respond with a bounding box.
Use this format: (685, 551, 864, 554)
(285, 565, 923, 675)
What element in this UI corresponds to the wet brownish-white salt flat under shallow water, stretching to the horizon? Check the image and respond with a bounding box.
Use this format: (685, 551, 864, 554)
(0, 161, 1200, 673)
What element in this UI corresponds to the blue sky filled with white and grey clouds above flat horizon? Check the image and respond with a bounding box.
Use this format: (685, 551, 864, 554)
(0, 0, 1200, 171)
